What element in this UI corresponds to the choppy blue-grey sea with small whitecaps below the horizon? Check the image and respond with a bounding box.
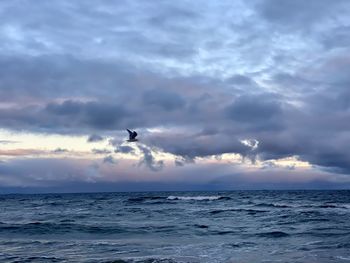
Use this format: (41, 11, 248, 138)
(0, 191, 350, 263)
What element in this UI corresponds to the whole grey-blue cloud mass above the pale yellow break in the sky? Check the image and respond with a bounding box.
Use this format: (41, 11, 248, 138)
(0, 0, 350, 184)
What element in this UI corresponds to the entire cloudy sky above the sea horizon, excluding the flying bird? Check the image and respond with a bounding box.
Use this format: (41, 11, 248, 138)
(0, 0, 350, 193)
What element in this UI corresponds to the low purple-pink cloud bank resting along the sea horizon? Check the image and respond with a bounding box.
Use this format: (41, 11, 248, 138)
(0, 158, 350, 192)
